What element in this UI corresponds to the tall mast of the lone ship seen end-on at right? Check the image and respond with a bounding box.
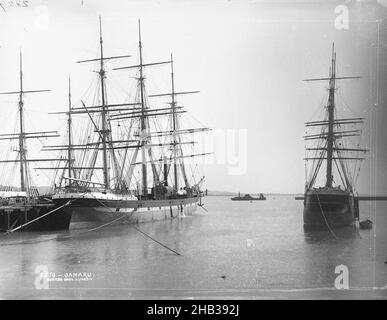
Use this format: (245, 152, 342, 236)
(325, 44, 336, 188)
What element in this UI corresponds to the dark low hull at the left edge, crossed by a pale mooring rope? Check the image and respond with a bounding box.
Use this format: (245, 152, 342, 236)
(0, 204, 71, 232)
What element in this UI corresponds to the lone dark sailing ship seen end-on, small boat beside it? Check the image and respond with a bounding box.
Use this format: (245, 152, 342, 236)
(303, 44, 367, 229)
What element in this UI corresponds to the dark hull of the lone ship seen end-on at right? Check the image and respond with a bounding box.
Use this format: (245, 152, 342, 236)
(303, 189, 355, 230)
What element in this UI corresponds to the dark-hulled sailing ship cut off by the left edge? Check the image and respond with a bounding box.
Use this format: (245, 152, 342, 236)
(0, 52, 71, 231)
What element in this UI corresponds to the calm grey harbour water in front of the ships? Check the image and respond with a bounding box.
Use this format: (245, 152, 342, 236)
(0, 196, 387, 299)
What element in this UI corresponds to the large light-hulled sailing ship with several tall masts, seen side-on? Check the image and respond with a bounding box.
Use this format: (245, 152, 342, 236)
(49, 19, 209, 223)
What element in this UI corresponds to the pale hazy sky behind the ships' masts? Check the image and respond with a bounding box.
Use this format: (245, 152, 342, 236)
(0, 0, 387, 193)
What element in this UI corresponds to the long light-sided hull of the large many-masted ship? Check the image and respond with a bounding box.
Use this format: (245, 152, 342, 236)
(53, 196, 200, 224)
